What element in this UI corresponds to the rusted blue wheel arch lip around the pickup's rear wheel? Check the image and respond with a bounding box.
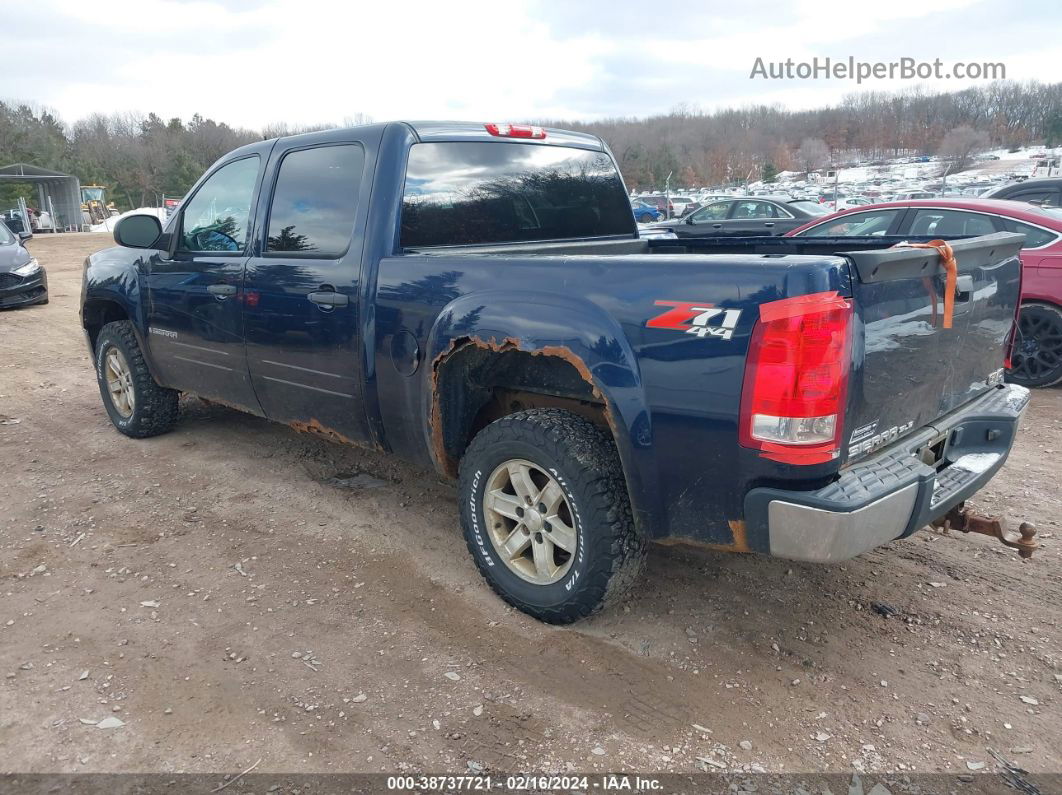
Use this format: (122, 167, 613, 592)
(422, 291, 663, 535)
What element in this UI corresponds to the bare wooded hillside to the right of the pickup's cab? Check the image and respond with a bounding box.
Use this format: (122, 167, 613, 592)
(539, 82, 1062, 188)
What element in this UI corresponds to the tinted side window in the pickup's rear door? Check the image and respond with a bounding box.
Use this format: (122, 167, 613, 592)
(266, 143, 365, 254)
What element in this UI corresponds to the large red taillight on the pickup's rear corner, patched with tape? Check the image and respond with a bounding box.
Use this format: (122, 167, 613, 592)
(738, 291, 852, 464)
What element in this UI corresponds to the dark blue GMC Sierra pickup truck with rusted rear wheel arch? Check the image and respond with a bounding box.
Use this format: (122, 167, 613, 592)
(82, 122, 1028, 623)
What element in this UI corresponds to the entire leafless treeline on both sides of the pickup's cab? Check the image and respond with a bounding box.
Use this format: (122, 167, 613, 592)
(0, 82, 1062, 209)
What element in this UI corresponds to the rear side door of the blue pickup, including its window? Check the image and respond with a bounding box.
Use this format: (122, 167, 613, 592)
(244, 131, 374, 442)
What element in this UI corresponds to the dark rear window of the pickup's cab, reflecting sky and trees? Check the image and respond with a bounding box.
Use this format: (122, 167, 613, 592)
(401, 141, 635, 248)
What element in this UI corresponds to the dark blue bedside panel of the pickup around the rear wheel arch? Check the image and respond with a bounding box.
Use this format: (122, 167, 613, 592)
(376, 255, 850, 549)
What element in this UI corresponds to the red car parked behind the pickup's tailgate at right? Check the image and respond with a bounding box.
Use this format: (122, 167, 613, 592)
(786, 198, 1062, 386)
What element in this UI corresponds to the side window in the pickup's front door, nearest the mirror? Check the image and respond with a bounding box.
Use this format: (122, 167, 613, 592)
(178, 155, 260, 252)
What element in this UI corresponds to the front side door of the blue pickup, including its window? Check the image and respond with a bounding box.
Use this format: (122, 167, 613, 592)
(147, 154, 263, 413)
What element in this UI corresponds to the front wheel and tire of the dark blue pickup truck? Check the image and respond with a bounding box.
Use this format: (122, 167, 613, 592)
(96, 321, 181, 438)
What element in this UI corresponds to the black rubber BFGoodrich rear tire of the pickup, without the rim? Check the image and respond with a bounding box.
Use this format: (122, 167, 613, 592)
(459, 409, 646, 624)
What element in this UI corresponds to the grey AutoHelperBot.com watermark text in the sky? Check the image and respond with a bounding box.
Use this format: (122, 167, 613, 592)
(749, 55, 1007, 84)
